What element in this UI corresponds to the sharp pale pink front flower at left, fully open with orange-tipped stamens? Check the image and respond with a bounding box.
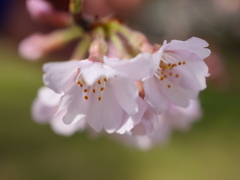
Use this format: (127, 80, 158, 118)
(43, 53, 153, 133)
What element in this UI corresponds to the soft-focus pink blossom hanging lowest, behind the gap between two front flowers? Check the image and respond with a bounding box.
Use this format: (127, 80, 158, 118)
(111, 97, 171, 150)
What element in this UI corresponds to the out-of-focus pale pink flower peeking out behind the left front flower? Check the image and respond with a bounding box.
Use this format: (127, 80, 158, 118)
(32, 87, 85, 136)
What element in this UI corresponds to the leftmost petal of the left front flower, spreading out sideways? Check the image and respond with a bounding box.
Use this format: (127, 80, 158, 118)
(43, 61, 79, 93)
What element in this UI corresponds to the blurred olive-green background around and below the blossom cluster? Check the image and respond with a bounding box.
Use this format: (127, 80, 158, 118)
(0, 1, 240, 180)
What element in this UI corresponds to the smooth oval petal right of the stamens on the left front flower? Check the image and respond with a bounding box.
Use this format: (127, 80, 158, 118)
(107, 77, 138, 115)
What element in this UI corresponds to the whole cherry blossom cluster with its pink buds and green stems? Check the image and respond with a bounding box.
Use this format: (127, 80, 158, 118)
(20, 0, 210, 148)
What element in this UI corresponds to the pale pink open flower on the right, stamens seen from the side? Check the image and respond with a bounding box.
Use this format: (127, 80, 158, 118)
(143, 37, 210, 114)
